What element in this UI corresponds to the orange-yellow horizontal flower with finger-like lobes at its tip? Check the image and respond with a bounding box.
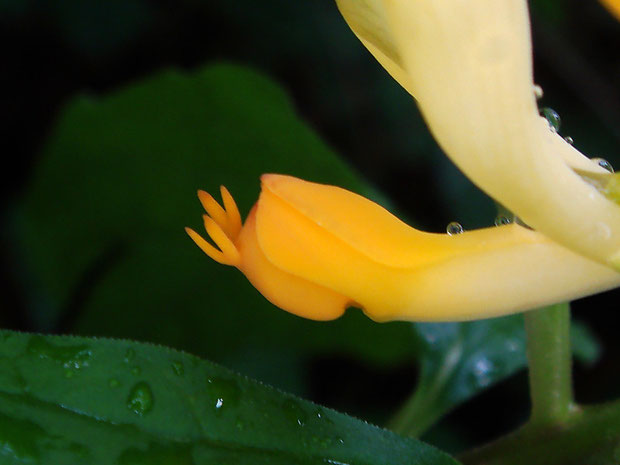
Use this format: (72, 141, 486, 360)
(186, 174, 620, 321)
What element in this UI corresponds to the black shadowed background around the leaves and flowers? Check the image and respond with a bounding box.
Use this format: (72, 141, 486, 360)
(0, 0, 620, 447)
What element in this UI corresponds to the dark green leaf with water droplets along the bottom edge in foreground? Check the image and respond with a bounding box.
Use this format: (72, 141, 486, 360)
(0, 331, 457, 465)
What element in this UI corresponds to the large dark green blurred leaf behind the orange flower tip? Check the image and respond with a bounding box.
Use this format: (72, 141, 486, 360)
(16, 65, 413, 392)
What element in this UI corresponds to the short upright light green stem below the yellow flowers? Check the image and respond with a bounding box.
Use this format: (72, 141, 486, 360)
(525, 303, 575, 425)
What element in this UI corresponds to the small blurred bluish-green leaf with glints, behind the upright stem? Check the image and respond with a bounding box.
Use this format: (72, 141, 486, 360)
(391, 314, 599, 436)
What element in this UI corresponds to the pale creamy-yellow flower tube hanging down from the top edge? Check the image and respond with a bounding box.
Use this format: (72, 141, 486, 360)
(336, 0, 620, 269)
